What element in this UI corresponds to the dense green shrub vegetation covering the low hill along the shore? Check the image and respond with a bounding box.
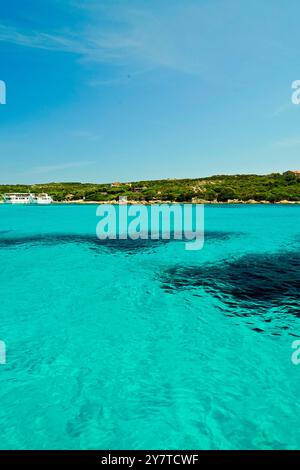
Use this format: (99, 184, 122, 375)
(0, 172, 300, 202)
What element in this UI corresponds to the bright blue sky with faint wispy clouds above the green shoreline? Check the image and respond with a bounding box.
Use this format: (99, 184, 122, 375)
(0, 0, 300, 183)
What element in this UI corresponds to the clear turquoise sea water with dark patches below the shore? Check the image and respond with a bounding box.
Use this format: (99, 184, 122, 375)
(0, 205, 300, 449)
